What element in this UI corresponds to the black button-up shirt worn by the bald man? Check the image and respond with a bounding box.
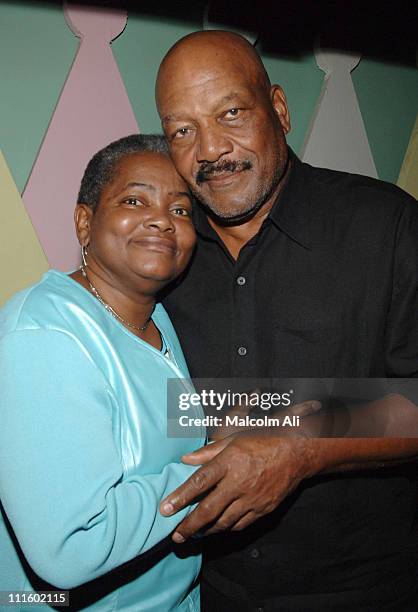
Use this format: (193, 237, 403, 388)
(164, 155, 418, 611)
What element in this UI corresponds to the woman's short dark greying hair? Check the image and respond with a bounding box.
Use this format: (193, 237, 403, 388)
(77, 134, 168, 211)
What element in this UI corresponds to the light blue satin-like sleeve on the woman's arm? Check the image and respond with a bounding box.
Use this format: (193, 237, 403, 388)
(0, 329, 196, 588)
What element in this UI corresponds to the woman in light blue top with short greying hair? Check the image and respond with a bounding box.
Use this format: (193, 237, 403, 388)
(0, 135, 204, 612)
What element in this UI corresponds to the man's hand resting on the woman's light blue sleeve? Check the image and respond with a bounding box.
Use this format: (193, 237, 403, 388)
(161, 432, 321, 543)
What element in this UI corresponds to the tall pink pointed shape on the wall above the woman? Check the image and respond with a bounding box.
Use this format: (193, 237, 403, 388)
(23, 4, 138, 270)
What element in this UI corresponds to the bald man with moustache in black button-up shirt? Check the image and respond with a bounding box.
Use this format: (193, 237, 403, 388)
(156, 32, 418, 612)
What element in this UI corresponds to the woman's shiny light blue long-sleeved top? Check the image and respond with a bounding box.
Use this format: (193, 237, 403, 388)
(0, 270, 205, 612)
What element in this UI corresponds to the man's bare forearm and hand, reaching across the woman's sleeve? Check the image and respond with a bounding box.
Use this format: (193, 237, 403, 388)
(161, 394, 418, 542)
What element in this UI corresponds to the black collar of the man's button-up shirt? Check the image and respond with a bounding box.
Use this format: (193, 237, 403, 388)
(193, 148, 311, 249)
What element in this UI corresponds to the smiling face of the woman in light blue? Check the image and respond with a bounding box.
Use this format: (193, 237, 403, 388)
(79, 152, 196, 288)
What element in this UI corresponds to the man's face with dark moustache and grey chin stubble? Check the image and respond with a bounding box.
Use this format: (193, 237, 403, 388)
(157, 63, 288, 220)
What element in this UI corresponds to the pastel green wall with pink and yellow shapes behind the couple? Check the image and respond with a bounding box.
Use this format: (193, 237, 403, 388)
(0, 2, 418, 303)
